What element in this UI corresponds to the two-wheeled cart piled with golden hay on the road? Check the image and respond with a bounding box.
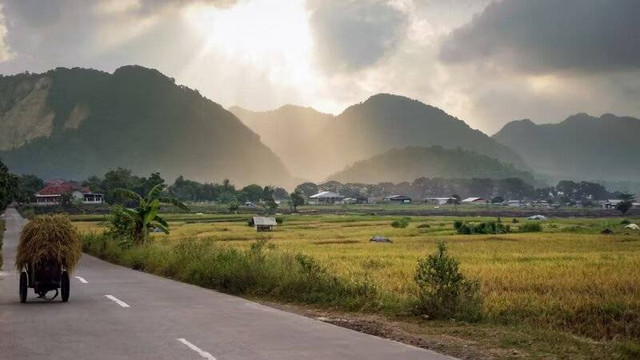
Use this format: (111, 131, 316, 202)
(16, 215, 82, 302)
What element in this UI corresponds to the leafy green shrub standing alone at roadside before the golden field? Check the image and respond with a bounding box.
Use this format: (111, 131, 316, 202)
(414, 242, 482, 321)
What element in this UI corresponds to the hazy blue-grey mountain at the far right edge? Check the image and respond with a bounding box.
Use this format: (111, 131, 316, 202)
(493, 114, 640, 181)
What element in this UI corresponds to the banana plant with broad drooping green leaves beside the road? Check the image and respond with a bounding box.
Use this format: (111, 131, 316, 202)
(114, 184, 189, 244)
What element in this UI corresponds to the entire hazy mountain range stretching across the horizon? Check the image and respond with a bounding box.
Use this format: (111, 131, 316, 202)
(0, 66, 640, 188)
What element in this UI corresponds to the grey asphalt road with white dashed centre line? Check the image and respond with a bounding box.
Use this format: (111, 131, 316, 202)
(0, 209, 452, 360)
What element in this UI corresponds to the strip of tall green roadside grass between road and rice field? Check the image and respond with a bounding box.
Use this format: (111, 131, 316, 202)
(84, 235, 393, 311)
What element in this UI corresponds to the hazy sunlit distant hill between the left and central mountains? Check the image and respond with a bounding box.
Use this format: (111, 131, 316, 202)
(229, 105, 338, 179)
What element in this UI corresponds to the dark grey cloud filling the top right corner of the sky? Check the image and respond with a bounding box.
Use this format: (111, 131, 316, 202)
(439, 0, 640, 73)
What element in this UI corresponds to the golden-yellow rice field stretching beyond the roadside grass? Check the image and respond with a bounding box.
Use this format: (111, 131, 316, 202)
(74, 214, 640, 348)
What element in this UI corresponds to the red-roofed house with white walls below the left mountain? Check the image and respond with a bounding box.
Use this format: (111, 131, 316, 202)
(36, 180, 104, 205)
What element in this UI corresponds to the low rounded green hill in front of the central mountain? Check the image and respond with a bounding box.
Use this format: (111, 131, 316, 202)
(329, 146, 535, 183)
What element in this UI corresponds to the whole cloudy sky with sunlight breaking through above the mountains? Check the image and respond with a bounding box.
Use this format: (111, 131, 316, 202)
(0, 0, 640, 134)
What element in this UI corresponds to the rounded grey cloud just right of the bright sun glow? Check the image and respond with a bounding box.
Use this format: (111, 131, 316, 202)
(309, 0, 406, 73)
